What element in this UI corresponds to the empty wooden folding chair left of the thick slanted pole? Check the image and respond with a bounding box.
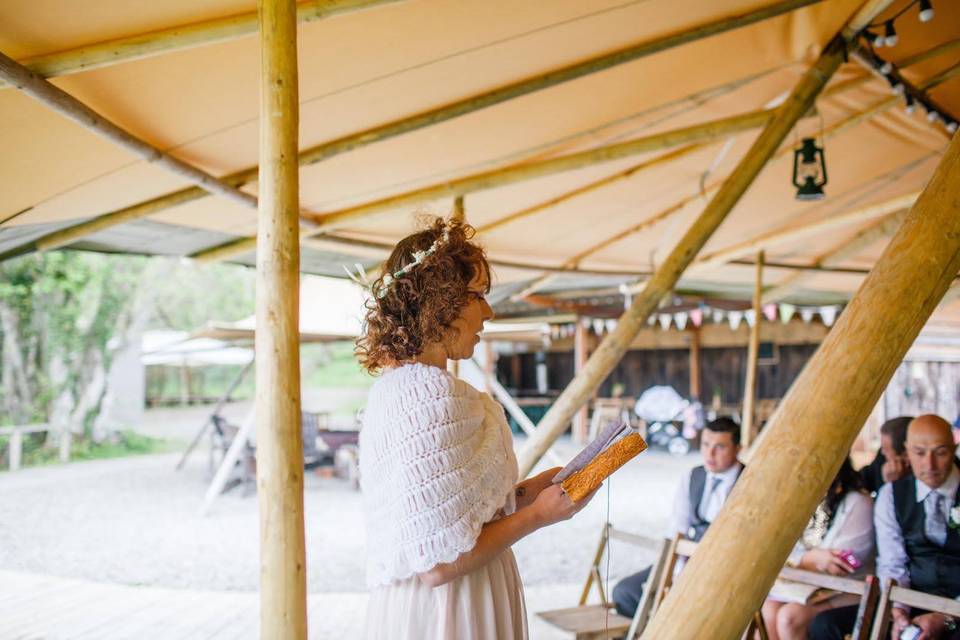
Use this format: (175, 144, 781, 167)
(537, 523, 667, 640)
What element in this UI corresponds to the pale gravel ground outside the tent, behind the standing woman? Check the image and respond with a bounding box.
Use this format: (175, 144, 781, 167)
(0, 430, 696, 593)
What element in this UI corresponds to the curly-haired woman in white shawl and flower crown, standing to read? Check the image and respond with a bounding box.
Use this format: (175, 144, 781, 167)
(357, 219, 587, 640)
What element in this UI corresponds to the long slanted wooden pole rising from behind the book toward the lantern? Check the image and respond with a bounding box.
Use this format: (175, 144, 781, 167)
(520, 31, 846, 476)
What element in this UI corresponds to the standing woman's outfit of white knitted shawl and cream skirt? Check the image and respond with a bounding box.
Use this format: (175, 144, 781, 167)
(360, 365, 527, 640)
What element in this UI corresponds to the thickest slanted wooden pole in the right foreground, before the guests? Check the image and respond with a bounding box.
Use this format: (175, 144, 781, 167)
(644, 105, 960, 640)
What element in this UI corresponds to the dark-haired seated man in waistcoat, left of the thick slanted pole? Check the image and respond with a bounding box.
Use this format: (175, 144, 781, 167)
(613, 417, 743, 618)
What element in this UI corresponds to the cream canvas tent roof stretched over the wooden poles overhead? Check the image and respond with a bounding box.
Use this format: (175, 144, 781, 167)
(0, 0, 960, 319)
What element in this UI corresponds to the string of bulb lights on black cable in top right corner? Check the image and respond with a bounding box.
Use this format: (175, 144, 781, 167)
(862, 0, 958, 135)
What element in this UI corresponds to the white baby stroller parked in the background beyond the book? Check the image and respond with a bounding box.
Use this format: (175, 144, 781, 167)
(633, 385, 703, 456)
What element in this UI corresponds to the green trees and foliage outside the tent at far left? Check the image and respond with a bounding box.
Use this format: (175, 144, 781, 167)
(0, 251, 254, 441)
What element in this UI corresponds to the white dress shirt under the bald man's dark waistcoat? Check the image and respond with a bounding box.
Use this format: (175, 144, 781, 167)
(874, 466, 960, 608)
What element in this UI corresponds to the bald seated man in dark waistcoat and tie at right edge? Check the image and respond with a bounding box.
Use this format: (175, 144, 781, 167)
(809, 415, 960, 640)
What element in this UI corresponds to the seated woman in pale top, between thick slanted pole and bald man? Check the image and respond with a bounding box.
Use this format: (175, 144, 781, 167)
(762, 458, 874, 640)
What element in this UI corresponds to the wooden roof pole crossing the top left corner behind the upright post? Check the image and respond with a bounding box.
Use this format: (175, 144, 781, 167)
(0, 0, 397, 89)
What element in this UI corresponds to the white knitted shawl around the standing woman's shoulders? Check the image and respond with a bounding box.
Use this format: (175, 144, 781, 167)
(360, 364, 518, 588)
